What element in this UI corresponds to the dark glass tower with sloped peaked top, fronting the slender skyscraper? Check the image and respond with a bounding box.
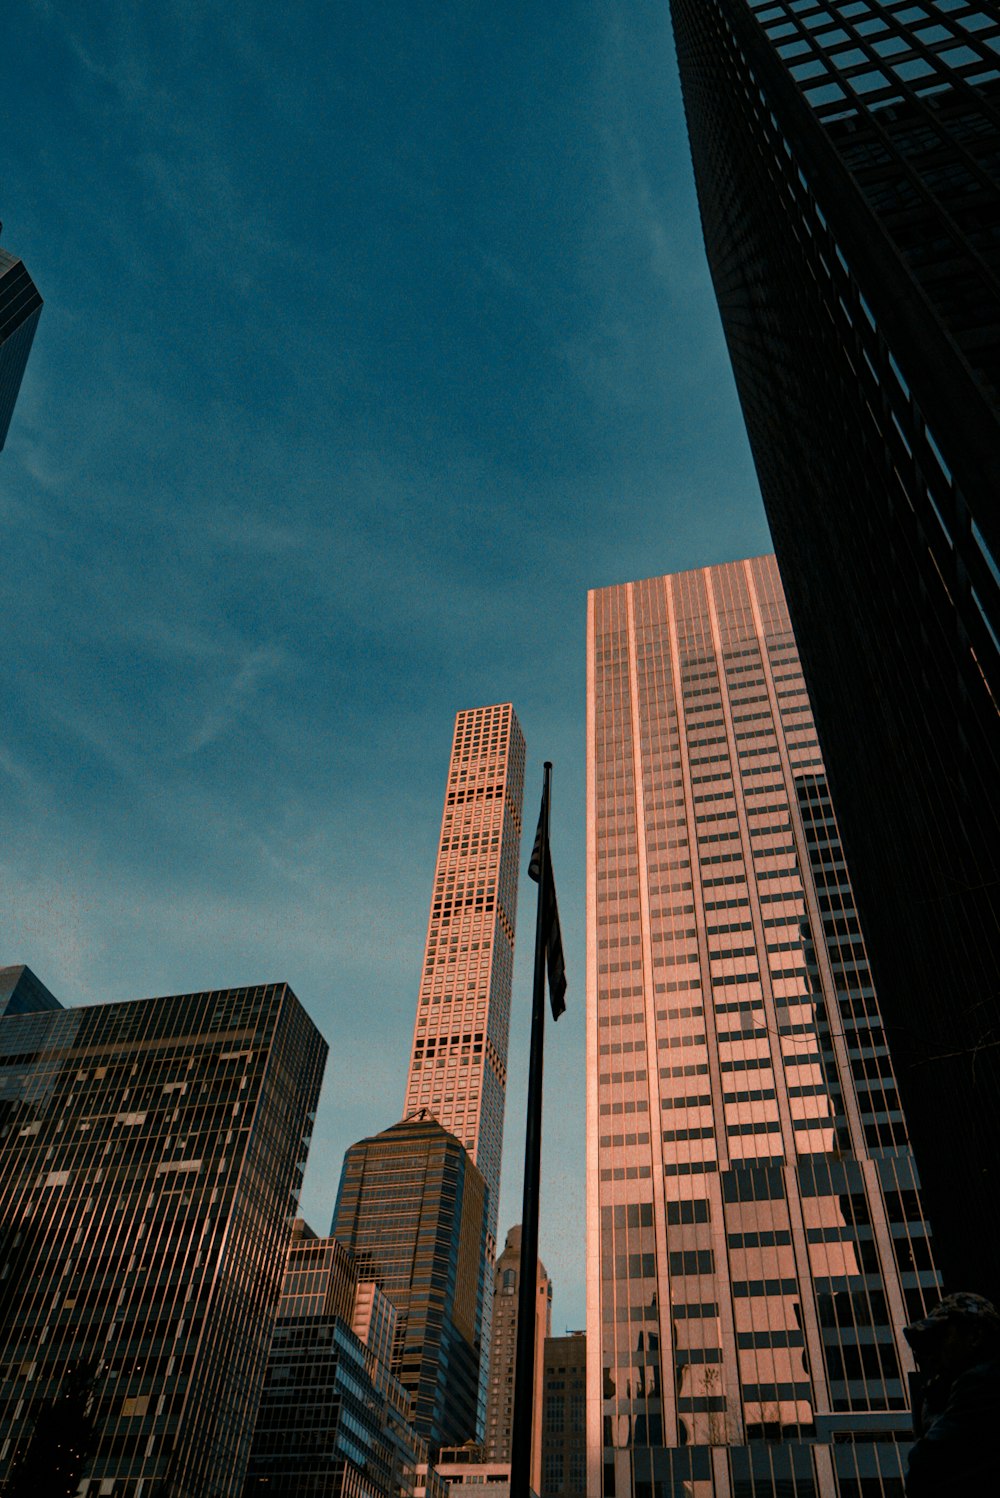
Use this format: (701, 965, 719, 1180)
(332, 1115, 487, 1455)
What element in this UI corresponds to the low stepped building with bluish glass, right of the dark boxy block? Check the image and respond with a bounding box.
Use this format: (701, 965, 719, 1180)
(244, 1221, 427, 1498)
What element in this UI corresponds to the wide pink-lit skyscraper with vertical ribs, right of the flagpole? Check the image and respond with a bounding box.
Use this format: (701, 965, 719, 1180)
(587, 557, 939, 1498)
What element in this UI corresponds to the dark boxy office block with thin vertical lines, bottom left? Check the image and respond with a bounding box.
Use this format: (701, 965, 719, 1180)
(0, 977, 326, 1498)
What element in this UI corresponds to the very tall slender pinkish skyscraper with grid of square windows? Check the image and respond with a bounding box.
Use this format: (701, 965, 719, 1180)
(404, 703, 524, 1266)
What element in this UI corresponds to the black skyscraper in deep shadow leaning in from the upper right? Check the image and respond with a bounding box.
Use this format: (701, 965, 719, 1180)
(671, 0, 1000, 1293)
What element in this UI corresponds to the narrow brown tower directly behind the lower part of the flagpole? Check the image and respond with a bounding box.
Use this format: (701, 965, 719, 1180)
(485, 1224, 552, 1492)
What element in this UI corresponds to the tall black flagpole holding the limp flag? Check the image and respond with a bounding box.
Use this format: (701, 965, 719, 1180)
(510, 759, 552, 1498)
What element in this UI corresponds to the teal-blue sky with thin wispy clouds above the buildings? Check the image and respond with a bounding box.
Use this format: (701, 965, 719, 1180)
(0, 0, 769, 1332)
